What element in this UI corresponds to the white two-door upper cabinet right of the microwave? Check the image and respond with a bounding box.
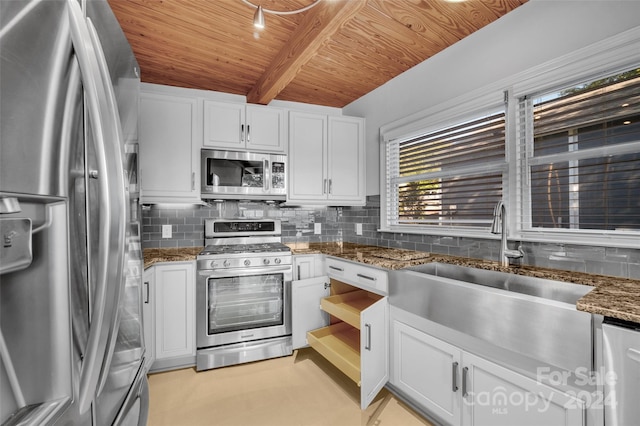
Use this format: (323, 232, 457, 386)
(287, 111, 365, 206)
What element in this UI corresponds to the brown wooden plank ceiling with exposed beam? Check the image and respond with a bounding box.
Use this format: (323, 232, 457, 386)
(109, 0, 527, 107)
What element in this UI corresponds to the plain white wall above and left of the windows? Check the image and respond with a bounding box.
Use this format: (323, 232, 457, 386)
(343, 0, 640, 195)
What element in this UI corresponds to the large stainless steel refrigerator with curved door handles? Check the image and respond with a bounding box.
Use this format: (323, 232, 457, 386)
(0, 0, 148, 425)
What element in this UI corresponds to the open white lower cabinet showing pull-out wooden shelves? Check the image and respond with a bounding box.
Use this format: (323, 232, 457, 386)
(292, 260, 389, 410)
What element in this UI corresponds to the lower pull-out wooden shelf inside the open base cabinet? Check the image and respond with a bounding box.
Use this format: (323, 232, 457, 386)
(307, 322, 360, 386)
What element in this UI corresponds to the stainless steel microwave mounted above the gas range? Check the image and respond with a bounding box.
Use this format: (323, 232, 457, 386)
(201, 149, 287, 201)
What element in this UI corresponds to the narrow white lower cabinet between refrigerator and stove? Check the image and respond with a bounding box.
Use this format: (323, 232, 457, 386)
(152, 262, 196, 370)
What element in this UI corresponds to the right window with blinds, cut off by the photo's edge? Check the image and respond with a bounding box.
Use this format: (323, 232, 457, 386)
(520, 68, 640, 231)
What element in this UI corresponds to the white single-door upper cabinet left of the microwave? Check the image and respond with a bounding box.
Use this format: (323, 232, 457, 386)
(139, 91, 202, 204)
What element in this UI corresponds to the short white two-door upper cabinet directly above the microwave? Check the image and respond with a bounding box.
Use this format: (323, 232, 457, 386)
(203, 101, 287, 153)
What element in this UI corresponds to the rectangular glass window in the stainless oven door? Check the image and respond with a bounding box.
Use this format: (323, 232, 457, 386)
(207, 273, 284, 335)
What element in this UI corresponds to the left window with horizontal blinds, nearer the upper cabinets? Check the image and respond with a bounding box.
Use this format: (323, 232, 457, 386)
(386, 109, 507, 229)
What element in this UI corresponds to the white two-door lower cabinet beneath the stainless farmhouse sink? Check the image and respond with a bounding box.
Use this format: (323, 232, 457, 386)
(391, 320, 586, 426)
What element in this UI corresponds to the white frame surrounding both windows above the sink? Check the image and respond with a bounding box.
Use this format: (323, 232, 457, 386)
(380, 27, 640, 248)
